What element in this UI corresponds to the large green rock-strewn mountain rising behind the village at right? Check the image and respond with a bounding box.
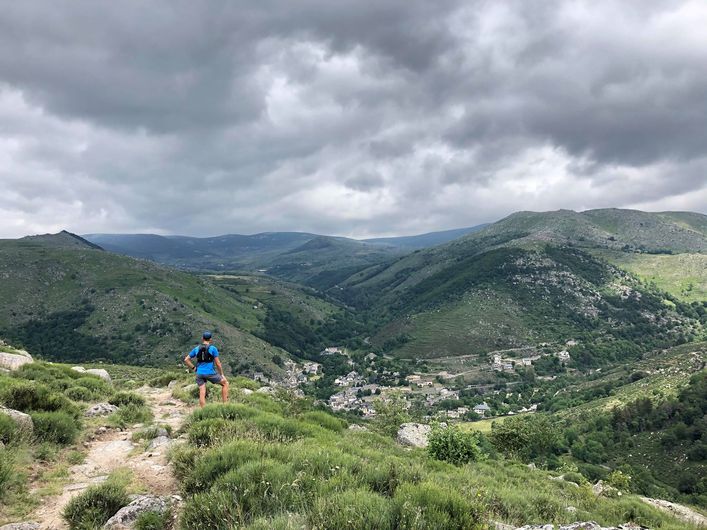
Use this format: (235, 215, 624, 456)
(338, 210, 707, 360)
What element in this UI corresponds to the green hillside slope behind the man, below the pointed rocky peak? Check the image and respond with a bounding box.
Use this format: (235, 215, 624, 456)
(0, 241, 296, 370)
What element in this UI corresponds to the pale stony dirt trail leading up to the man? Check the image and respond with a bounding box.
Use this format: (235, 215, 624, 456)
(30, 387, 191, 530)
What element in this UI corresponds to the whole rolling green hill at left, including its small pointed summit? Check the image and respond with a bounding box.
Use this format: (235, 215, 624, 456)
(0, 233, 338, 373)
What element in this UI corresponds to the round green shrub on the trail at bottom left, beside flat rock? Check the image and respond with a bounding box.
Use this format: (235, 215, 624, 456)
(63, 480, 130, 530)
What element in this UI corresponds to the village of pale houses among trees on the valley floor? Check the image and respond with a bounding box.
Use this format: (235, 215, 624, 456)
(254, 340, 577, 421)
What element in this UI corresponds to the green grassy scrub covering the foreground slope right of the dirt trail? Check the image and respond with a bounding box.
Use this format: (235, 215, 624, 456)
(170, 395, 682, 530)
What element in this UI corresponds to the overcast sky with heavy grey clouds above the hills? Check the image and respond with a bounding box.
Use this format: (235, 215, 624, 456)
(0, 0, 707, 237)
